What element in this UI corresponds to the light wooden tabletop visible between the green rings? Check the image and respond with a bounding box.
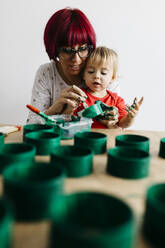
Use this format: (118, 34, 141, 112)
(1, 129, 165, 248)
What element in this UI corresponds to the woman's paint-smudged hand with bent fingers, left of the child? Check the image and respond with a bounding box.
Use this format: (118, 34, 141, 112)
(45, 85, 87, 115)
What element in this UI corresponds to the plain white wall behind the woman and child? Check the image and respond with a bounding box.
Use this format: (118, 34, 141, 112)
(0, 0, 165, 130)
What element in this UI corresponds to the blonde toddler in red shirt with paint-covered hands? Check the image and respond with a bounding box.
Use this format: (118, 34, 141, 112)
(74, 47, 143, 128)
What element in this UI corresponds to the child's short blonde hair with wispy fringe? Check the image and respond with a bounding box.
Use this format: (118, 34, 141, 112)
(86, 46, 118, 80)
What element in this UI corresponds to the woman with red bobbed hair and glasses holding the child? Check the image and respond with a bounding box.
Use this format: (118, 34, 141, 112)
(27, 8, 119, 123)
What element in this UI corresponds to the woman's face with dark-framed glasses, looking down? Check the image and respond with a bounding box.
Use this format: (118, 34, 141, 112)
(58, 44, 89, 76)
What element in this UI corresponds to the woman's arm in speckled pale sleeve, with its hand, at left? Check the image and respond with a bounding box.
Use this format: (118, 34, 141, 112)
(27, 65, 86, 123)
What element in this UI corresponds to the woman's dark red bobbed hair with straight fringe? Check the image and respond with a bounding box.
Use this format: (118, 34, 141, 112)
(44, 8, 96, 59)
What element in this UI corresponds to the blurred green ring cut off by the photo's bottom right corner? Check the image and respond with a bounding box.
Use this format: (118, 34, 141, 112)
(143, 183, 165, 248)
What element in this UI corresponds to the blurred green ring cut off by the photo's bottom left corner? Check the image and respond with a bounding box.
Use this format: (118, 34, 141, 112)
(0, 197, 14, 248)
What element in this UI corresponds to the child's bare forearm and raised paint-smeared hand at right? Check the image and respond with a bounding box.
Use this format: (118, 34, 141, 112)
(118, 97, 144, 128)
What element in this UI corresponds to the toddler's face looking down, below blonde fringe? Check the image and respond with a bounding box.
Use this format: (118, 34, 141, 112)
(83, 60, 113, 92)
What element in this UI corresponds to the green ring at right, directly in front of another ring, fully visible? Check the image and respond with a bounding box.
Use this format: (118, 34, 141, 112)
(107, 146, 150, 179)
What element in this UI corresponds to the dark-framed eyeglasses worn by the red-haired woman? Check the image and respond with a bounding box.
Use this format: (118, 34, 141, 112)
(59, 45, 93, 59)
